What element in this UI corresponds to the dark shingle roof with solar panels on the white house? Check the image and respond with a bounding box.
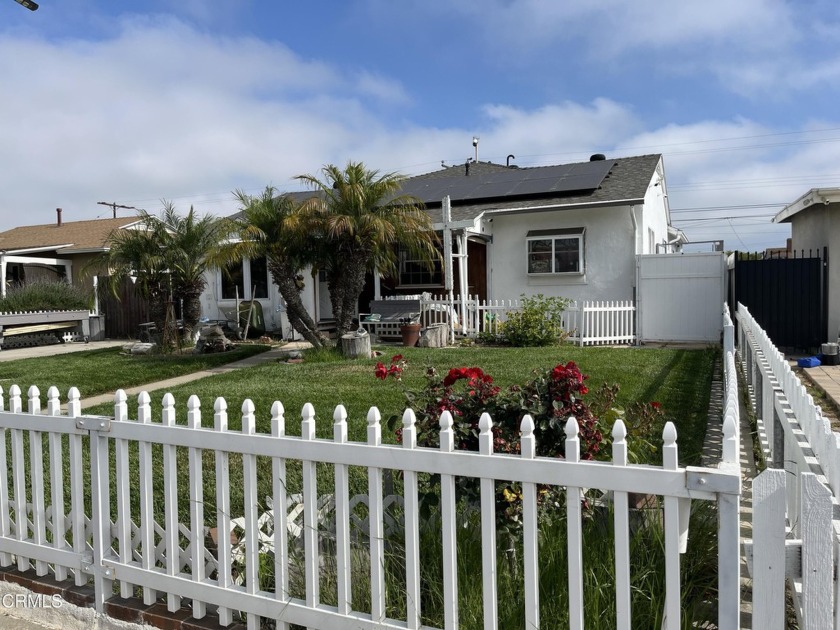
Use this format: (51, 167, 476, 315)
(262, 154, 662, 221)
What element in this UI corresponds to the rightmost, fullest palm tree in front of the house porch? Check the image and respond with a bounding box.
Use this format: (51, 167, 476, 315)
(296, 162, 439, 337)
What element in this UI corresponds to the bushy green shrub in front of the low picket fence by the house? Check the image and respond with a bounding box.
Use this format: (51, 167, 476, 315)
(499, 293, 571, 347)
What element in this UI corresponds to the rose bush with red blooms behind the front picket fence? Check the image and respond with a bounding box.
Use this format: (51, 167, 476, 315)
(374, 355, 664, 530)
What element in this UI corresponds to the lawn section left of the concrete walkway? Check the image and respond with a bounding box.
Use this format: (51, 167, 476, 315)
(0, 344, 270, 400)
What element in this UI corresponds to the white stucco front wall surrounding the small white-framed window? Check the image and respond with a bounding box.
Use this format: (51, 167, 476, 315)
(485, 206, 636, 300)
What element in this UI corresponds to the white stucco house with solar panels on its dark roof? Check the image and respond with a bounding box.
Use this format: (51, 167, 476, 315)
(203, 154, 686, 332)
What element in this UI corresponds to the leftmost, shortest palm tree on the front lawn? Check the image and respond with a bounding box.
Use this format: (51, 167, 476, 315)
(95, 201, 231, 348)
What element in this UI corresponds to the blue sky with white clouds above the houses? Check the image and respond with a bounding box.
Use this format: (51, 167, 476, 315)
(0, 0, 840, 250)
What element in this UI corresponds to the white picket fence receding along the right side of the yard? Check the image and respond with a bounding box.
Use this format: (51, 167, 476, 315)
(736, 304, 840, 629)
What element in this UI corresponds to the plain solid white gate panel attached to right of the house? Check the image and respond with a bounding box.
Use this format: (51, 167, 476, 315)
(636, 252, 726, 343)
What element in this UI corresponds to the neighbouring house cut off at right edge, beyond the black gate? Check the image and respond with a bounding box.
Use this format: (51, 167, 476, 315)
(773, 188, 840, 341)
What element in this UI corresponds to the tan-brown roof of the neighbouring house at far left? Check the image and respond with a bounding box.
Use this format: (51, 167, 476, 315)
(0, 217, 139, 254)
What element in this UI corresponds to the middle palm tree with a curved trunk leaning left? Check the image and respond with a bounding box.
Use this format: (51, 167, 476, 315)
(224, 186, 325, 348)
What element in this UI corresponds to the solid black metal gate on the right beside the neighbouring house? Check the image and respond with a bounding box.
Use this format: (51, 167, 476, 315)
(729, 248, 833, 352)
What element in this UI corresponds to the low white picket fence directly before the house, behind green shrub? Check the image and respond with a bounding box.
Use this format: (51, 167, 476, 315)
(412, 295, 636, 346)
